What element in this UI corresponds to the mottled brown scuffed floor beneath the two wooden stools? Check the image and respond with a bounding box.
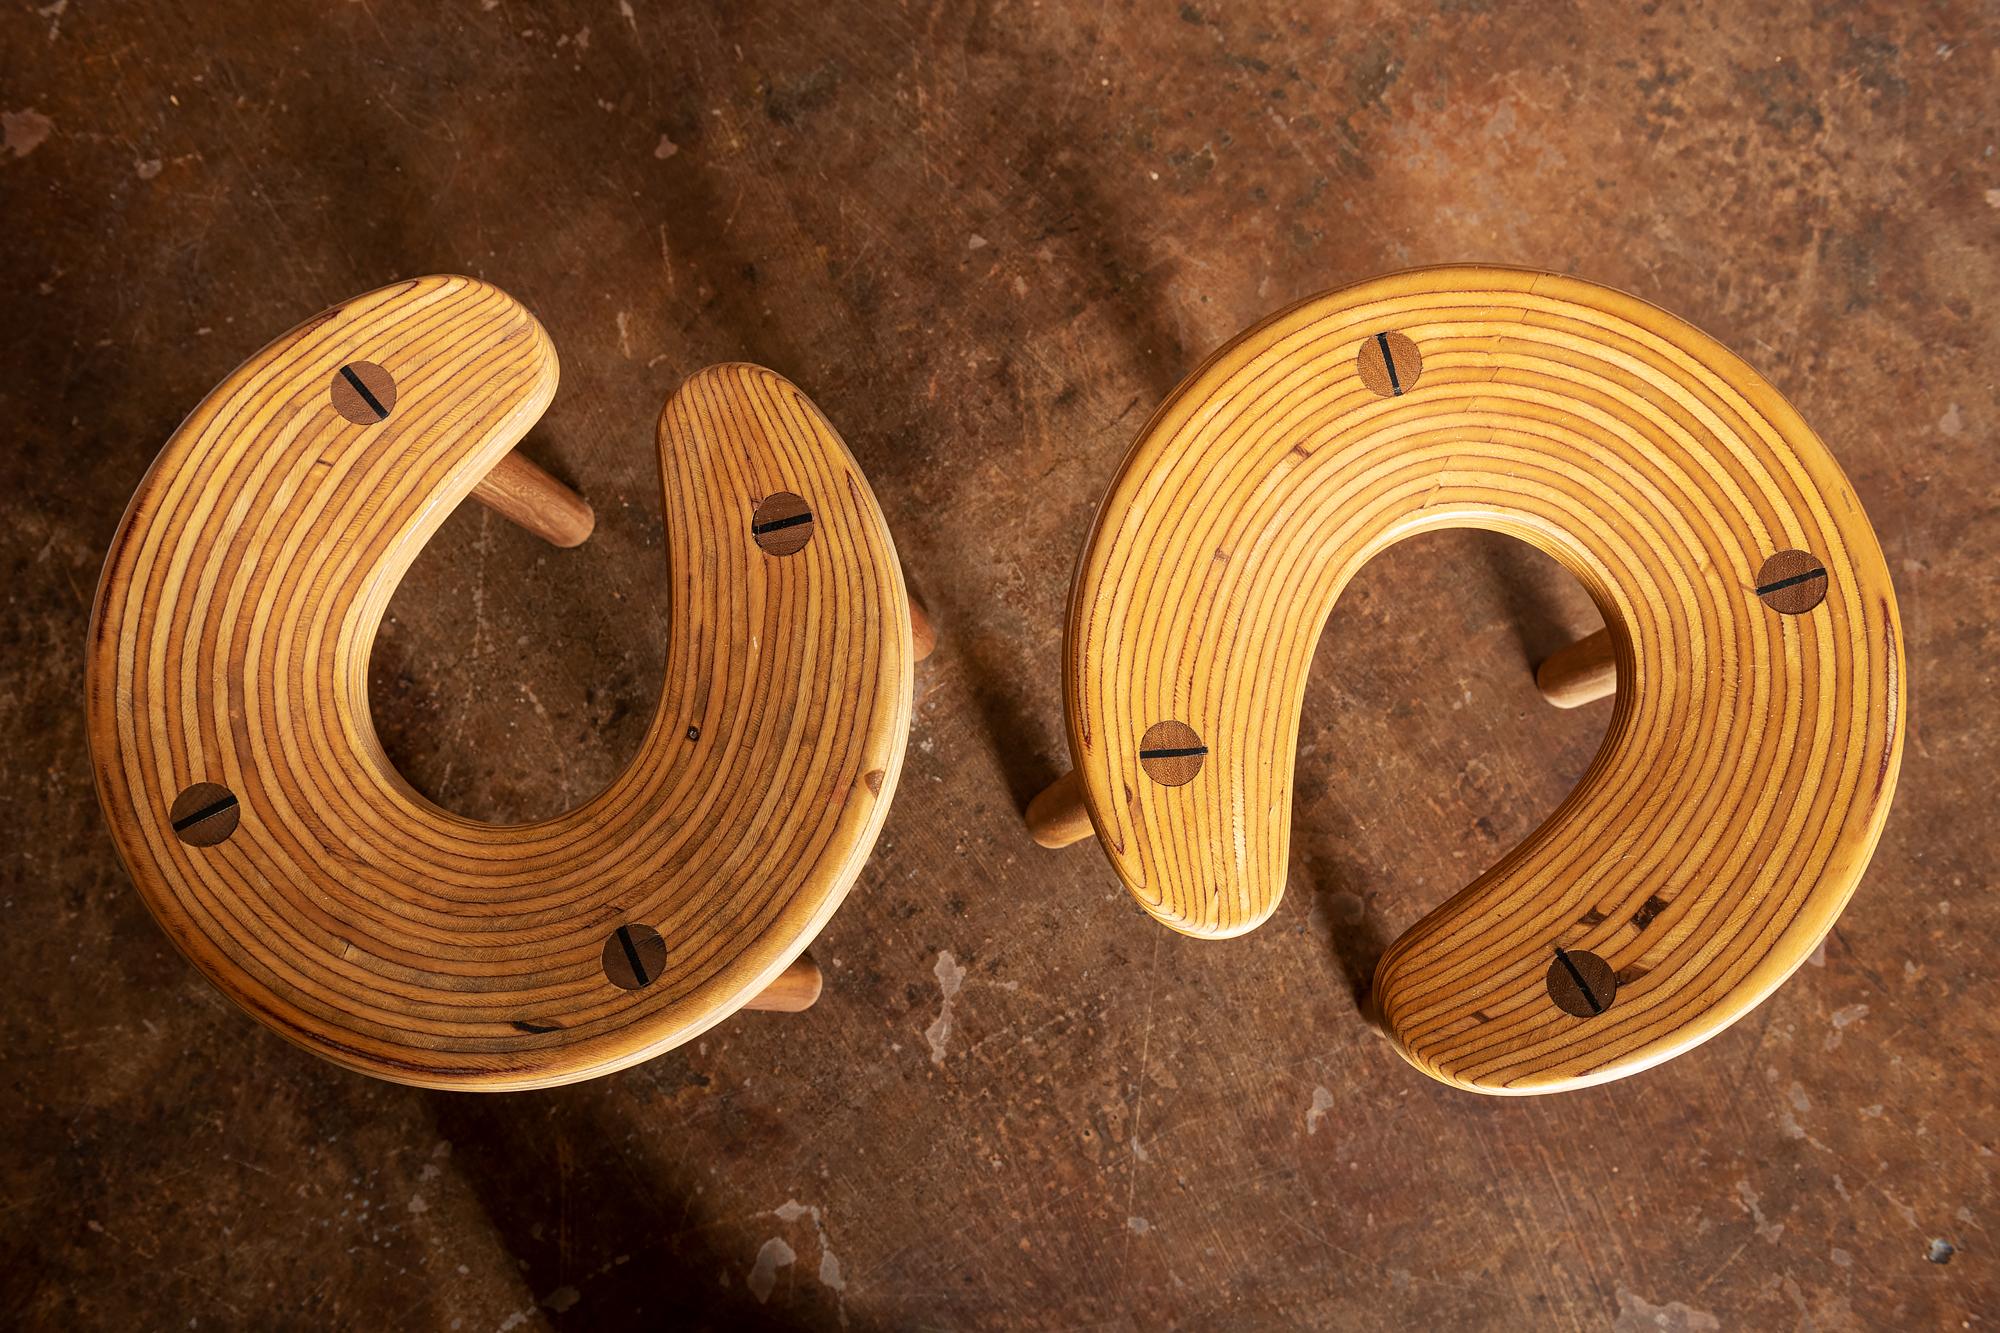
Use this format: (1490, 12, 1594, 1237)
(0, 0, 2000, 1331)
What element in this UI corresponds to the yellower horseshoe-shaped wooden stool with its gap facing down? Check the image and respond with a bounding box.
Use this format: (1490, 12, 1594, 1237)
(1028, 268, 1904, 1093)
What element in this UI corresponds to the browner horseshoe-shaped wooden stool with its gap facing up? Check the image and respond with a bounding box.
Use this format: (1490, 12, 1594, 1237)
(88, 276, 928, 1089)
